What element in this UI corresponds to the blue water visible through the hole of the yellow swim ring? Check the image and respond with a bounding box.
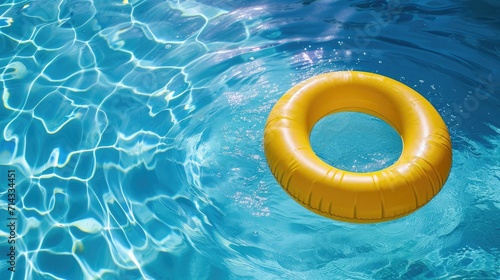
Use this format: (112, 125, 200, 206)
(310, 112, 403, 172)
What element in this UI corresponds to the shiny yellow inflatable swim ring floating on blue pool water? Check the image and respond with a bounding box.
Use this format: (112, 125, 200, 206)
(264, 71, 452, 223)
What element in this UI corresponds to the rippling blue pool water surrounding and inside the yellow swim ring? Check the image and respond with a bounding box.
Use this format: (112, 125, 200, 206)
(0, 0, 500, 279)
